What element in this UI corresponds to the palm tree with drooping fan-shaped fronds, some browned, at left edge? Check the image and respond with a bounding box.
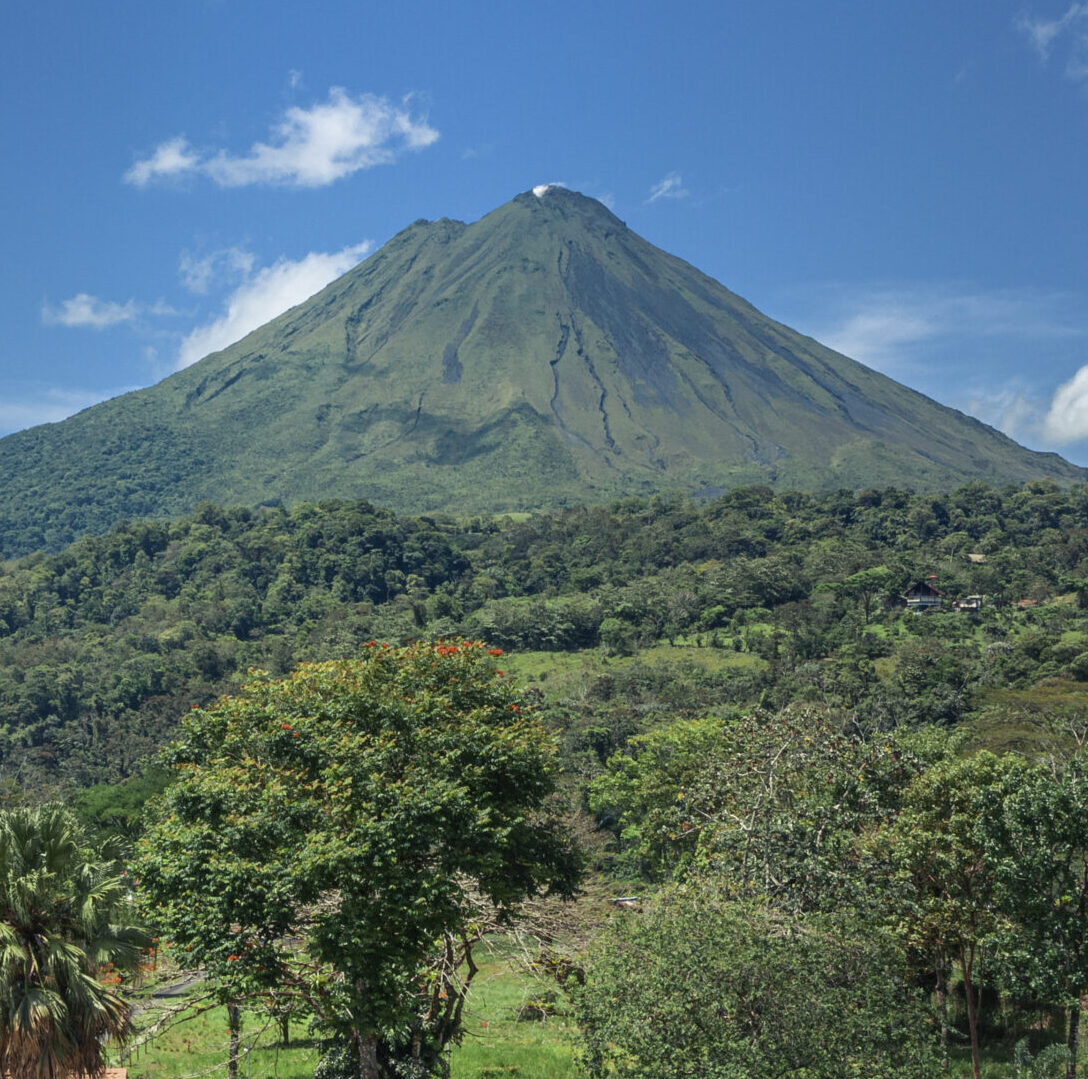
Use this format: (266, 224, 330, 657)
(0, 806, 146, 1079)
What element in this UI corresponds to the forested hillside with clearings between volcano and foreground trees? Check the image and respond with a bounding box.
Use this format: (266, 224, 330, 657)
(6, 482, 1088, 793)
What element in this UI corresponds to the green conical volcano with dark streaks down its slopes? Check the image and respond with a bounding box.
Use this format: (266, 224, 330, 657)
(0, 188, 1088, 555)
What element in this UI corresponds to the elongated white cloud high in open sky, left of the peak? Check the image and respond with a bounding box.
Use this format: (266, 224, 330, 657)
(124, 86, 438, 187)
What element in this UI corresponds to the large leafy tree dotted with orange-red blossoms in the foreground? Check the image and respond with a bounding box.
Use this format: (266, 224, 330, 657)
(139, 641, 578, 1079)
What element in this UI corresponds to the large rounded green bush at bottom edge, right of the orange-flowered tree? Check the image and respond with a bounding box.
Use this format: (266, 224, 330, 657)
(574, 886, 936, 1079)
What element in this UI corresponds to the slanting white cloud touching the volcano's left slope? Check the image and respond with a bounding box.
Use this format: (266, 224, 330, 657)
(177, 241, 371, 370)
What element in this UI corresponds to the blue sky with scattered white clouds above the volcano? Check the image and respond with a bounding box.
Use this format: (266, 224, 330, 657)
(6, 0, 1088, 464)
